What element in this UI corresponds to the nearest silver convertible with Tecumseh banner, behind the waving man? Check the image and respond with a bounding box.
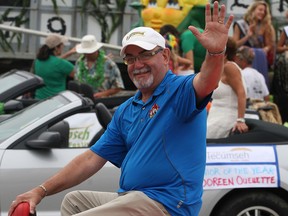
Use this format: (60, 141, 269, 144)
(0, 91, 288, 216)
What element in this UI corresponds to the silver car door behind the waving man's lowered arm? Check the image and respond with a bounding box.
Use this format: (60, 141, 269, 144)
(0, 145, 119, 216)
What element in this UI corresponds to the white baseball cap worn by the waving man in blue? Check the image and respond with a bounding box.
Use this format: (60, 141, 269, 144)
(120, 27, 165, 56)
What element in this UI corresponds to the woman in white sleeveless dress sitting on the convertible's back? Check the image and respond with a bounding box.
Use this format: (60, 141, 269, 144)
(207, 37, 248, 139)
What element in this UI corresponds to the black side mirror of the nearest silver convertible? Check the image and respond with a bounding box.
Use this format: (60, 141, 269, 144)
(25, 131, 61, 149)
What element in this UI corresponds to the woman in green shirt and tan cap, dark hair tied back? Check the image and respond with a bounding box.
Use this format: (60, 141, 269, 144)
(33, 34, 74, 99)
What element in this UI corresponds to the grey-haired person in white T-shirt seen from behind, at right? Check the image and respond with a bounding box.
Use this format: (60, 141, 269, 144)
(235, 46, 269, 101)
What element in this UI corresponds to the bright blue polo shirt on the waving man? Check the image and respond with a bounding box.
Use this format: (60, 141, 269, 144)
(91, 71, 211, 216)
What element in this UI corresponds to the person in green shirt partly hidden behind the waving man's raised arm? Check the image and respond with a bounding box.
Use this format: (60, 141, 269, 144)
(180, 28, 206, 73)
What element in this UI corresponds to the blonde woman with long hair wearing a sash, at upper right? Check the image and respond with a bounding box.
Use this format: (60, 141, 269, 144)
(233, 1, 276, 86)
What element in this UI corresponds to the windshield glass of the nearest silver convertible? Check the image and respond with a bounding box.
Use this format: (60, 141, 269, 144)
(0, 95, 69, 143)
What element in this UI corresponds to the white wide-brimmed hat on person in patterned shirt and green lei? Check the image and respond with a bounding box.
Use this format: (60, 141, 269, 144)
(76, 35, 103, 54)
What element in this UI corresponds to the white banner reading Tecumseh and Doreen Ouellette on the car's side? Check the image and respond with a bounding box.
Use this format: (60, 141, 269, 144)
(203, 145, 279, 190)
